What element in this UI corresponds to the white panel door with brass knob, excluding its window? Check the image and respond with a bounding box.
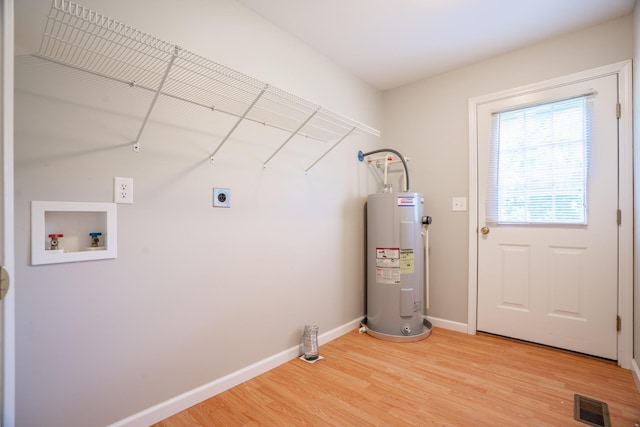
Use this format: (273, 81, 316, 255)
(477, 74, 618, 359)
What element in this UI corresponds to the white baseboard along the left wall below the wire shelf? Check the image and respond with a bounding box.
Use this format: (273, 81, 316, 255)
(109, 317, 362, 427)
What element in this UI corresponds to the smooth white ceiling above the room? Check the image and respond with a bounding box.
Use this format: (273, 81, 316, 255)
(238, 0, 635, 90)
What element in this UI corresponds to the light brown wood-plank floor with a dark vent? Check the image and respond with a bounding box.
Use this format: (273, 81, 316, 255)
(155, 328, 640, 427)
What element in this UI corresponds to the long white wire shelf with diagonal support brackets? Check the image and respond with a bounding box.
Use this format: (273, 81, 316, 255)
(36, 0, 380, 171)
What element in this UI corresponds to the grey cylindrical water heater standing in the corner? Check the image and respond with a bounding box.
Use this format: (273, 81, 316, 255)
(361, 149, 431, 342)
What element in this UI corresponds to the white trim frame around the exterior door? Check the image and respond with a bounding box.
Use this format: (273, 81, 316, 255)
(467, 60, 633, 369)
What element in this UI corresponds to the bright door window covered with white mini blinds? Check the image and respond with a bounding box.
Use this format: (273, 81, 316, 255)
(487, 95, 590, 224)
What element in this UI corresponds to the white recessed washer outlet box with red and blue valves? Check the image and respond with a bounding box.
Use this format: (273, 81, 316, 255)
(31, 201, 118, 265)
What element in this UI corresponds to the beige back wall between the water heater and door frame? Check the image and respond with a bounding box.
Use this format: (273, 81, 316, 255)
(383, 16, 633, 323)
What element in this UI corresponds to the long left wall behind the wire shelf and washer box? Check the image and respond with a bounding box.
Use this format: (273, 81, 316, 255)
(15, 0, 382, 427)
